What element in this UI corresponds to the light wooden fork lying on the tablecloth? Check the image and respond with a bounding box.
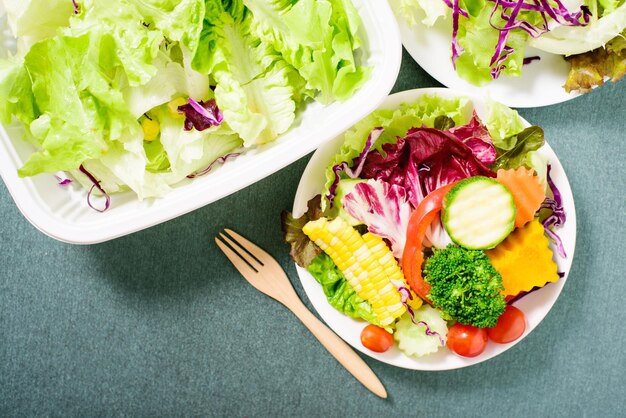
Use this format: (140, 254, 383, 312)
(215, 229, 387, 398)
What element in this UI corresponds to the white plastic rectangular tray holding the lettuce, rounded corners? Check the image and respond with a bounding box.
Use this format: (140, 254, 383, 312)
(0, 0, 402, 244)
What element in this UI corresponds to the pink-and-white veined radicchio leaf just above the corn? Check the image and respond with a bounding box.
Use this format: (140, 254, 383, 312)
(342, 180, 411, 259)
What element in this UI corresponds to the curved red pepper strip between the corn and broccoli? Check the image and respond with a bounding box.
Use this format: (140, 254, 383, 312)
(402, 183, 455, 303)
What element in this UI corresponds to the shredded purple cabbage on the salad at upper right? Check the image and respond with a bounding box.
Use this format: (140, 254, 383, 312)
(443, 0, 591, 79)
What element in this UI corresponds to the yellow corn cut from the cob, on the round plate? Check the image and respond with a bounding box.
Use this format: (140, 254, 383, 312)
(302, 218, 406, 326)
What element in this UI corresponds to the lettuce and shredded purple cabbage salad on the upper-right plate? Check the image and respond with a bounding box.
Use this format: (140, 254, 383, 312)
(391, 0, 626, 93)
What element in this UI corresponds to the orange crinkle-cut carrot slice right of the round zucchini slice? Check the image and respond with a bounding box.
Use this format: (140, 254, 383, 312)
(496, 167, 546, 228)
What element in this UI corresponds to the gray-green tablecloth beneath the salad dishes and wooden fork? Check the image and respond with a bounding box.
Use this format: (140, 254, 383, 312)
(0, 50, 626, 417)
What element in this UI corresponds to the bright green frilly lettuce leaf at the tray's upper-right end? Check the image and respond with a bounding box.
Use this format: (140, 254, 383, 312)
(244, 0, 371, 103)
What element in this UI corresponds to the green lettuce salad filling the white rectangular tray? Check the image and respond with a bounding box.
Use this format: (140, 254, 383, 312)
(0, 0, 371, 209)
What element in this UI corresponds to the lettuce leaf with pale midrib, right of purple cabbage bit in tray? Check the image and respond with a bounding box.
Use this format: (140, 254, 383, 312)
(195, 10, 297, 147)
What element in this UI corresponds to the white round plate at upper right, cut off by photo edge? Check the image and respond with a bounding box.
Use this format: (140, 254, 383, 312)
(396, 9, 580, 107)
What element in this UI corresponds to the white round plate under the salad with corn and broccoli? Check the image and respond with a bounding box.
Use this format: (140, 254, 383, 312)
(293, 88, 576, 370)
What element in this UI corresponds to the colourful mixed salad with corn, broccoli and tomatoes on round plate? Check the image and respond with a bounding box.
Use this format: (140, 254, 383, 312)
(282, 89, 574, 367)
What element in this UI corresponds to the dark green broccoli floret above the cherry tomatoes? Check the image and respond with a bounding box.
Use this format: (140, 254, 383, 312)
(424, 244, 506, 328)
